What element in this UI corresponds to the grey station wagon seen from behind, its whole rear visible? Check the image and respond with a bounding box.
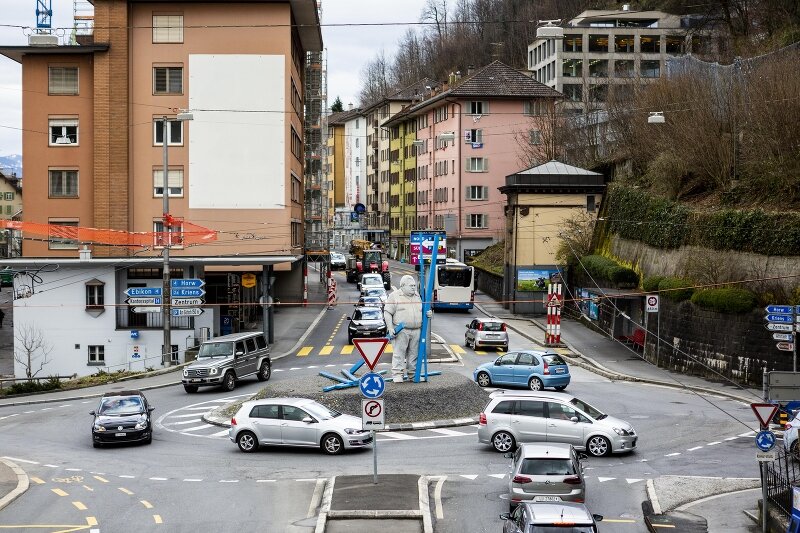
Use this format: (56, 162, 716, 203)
(507, 442, 586, 511)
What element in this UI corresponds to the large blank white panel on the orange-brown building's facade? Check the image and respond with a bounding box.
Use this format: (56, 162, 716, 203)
(188, 54, 286, 209)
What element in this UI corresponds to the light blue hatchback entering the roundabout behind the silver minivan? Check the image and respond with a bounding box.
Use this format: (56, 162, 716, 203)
(473, 350, 570, 390)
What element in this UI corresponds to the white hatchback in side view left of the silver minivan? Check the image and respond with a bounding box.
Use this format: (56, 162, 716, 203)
(228, 398, 372, 455)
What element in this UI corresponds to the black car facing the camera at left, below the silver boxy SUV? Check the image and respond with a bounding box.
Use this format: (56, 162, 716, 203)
(89, 390, 155, 448)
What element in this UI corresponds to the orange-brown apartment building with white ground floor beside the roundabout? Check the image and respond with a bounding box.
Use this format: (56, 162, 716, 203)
(0, 0, 322, 375)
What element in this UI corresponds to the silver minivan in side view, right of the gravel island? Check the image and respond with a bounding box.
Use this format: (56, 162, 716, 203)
(478, 391, 638, 457)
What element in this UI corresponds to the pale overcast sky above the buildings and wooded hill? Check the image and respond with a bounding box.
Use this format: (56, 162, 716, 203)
(0, 0, 426, 157)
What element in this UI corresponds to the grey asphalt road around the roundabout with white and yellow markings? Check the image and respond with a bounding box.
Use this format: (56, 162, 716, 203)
(0, 273, 758, 533)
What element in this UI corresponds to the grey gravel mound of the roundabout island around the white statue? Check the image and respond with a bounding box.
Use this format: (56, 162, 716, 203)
(212, 373, 489, 424)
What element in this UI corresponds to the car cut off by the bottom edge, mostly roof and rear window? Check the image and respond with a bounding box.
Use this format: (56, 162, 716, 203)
(500, 502, 603, 533)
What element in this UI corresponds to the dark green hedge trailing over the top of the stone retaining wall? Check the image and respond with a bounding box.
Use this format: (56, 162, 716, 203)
(604, 183, 800, 256)
